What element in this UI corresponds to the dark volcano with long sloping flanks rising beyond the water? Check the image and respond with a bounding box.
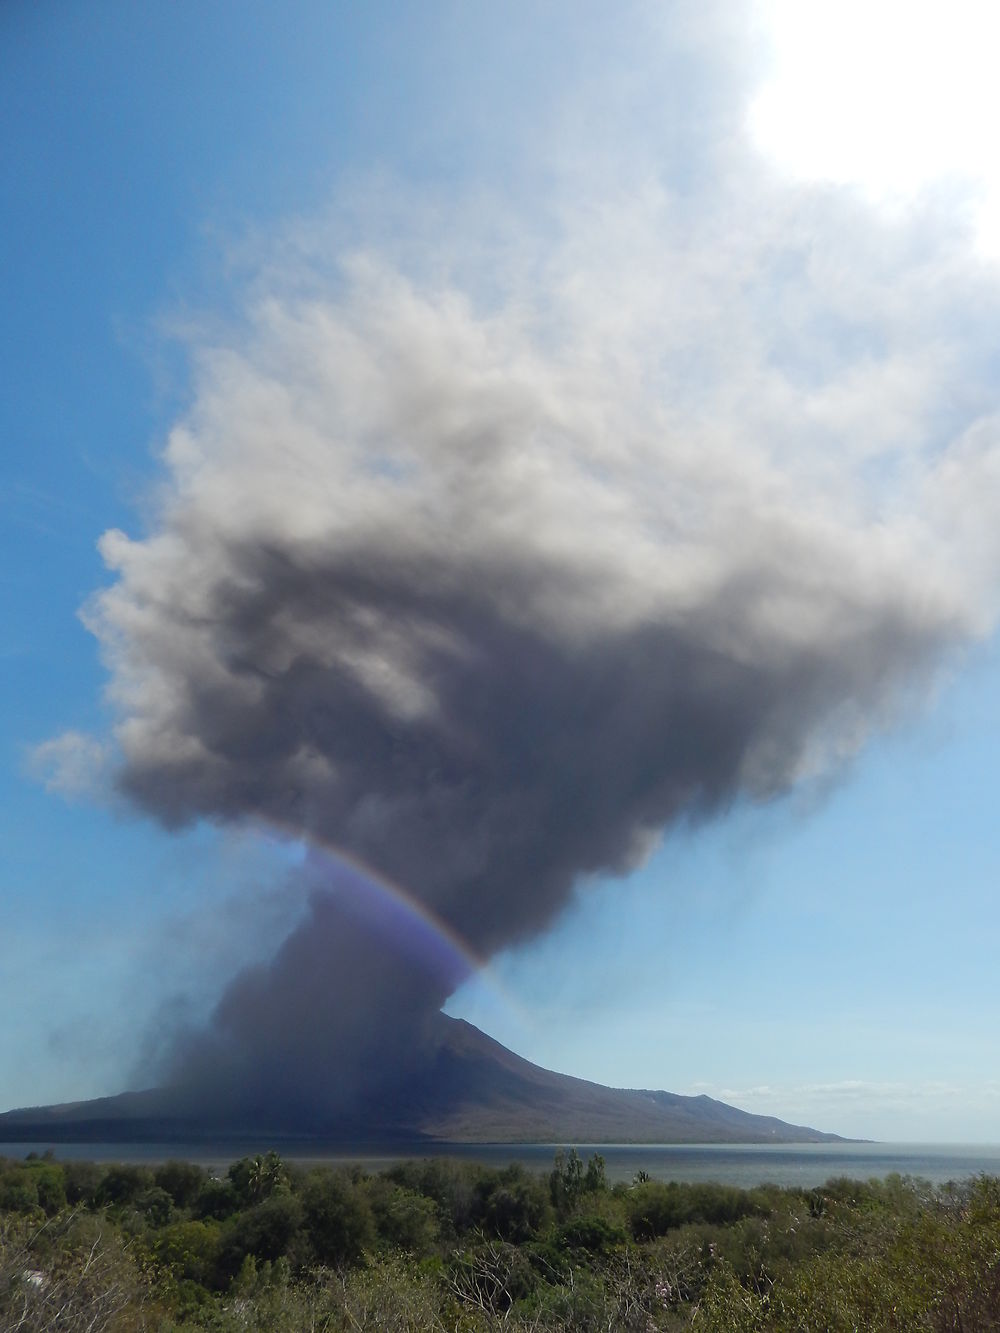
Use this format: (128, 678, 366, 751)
(0, 1014, 844, 1145)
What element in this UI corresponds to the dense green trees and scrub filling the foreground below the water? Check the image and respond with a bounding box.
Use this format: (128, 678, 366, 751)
(0, 1152, 1000, 1333)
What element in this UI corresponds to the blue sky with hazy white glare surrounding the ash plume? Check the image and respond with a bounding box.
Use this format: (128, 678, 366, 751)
(0, 0, 1000, 1141)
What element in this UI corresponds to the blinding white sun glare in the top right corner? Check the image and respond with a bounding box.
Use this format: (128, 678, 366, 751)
(749, 0, 1000, 257)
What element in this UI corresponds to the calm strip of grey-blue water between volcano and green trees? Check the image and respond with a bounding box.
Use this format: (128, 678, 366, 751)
(0, 1142, 1000, 1188)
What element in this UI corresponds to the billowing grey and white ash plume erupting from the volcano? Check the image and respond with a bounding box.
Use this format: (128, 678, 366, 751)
(88, 207, 995, 1113)
